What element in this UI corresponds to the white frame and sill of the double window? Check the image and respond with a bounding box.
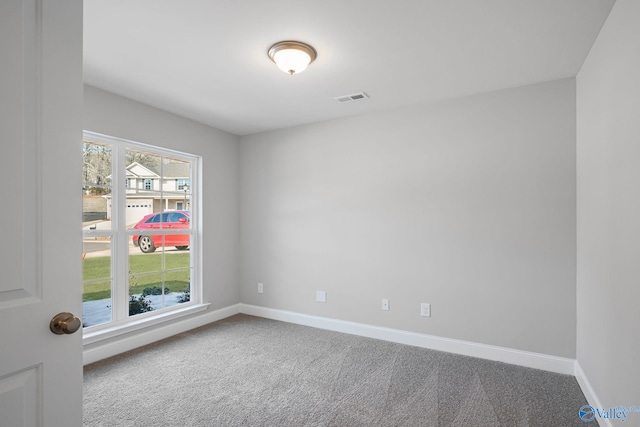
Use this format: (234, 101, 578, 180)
(83, 131, 204, 345)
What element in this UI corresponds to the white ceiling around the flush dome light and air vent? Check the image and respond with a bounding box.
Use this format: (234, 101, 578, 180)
(84, 0, 614, 135)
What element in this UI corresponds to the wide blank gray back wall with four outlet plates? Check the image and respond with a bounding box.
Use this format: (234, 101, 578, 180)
(240, 79, 576, 358)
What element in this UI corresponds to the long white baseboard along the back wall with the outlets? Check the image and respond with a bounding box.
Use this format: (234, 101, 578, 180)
(240, 304, 575, 375)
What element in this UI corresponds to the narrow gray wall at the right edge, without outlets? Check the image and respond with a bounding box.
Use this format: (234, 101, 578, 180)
(577, 0, 640, 408)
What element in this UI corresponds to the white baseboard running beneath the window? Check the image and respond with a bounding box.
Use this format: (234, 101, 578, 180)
(82, 304, 240, 365)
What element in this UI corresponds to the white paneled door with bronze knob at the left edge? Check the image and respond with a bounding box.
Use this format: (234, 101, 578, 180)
(0, 0, 82, 427)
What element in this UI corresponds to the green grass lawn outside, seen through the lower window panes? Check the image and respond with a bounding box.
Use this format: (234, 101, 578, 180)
(82, 252, 190, 301)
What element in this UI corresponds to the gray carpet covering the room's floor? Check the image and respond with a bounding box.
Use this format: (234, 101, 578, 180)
(84, 315, 596, 427)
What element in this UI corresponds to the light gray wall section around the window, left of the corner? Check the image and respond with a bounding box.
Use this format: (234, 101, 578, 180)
(84, 85, 240, 309)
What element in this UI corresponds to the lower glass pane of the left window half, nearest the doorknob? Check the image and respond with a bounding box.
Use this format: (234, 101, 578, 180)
(82, 241, 113, 328)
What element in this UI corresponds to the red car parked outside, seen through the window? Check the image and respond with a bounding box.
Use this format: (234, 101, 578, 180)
(133, 211, 191, 254)
